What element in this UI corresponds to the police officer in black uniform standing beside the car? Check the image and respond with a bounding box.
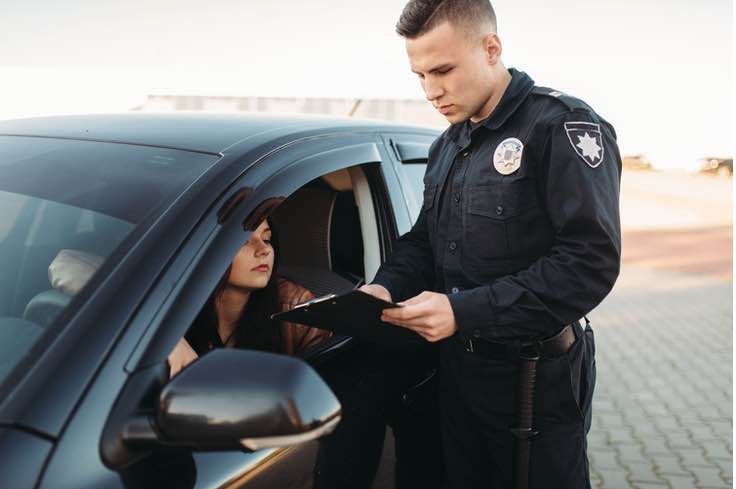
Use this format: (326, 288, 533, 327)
(362, 0, 621, 489)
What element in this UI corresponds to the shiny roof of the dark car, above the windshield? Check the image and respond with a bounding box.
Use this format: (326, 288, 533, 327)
(0, 112, 436, 154)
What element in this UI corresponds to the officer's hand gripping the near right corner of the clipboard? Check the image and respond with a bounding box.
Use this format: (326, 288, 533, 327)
(381, 291, 457, 341)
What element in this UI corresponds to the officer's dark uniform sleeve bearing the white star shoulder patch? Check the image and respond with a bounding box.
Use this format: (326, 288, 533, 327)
(449, 111, 621, 337)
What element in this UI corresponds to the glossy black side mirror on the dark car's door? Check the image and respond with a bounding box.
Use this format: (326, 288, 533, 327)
(155, 348, 340, 450)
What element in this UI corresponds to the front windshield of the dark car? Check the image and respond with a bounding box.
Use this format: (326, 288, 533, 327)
(0, 136, 218, 383)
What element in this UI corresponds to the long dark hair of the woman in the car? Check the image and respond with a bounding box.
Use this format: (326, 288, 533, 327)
(186, 218, 283, 355)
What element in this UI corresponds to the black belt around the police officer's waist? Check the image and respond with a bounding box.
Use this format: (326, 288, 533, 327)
(461, 324, 576, 359)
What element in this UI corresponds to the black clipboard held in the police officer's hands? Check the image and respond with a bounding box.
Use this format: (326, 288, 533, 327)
(271, 289, 424, 346)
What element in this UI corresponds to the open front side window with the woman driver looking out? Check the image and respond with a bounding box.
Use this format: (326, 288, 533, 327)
(169, 170, 364, 374)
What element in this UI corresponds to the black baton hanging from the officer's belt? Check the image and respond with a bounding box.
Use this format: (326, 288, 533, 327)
(511, 343, 539, 489)
